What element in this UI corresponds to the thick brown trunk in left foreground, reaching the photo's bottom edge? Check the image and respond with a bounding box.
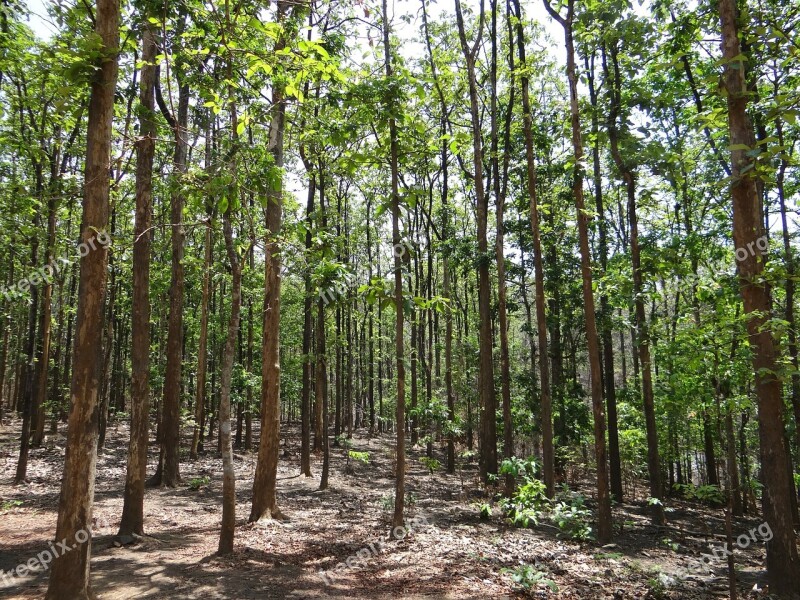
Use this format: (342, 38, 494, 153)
(46, 0, 119, 600)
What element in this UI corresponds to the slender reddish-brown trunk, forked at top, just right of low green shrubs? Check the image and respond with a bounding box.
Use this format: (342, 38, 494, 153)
(544, 0, 612, 544)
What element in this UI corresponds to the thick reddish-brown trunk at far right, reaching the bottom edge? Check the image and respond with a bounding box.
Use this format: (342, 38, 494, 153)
(719, 0, 800, 598)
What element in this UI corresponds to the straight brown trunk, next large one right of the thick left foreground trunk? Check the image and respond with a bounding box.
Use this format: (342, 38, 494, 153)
(118, 23, 156, 536)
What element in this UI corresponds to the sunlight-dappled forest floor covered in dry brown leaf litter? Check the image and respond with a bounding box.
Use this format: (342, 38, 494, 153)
(0, 421, 788, 600)
